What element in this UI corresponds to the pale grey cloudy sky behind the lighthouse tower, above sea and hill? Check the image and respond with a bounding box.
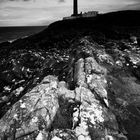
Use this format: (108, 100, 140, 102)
(0, 0, 140, 26)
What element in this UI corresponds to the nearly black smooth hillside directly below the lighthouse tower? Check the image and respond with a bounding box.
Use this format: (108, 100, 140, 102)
(27, 11, 140, 47)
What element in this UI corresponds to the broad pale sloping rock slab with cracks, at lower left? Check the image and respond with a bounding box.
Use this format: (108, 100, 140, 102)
(0, 76, 59, 139)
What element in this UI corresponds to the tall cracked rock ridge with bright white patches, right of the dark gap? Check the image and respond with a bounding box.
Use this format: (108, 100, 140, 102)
(68, 40, 118, 140)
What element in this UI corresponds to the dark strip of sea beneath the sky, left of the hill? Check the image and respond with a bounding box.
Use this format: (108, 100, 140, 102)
(0, 26, 47, 43)
